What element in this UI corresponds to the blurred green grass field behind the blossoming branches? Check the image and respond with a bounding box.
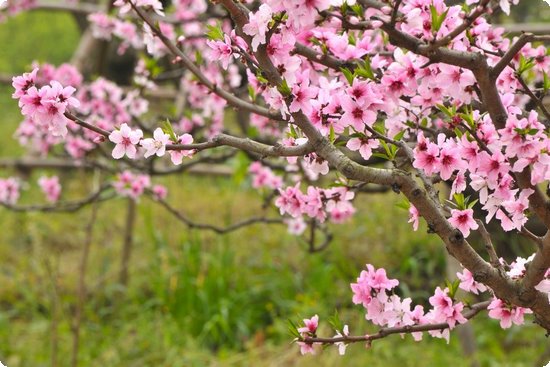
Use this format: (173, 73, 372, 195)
(0, 12, 550, 367)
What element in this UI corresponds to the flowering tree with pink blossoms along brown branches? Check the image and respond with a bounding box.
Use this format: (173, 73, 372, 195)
(0, 0, 550, 360)
